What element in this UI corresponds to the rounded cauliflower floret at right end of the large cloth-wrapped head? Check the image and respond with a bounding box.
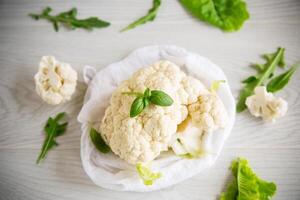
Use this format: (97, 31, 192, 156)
(188, 92, 228, 132)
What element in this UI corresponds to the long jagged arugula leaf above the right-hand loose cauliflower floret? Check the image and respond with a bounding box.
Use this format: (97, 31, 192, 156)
(236, 47, 284, 112)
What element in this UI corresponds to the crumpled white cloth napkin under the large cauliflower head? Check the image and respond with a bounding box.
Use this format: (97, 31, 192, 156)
(78, 45, 235, 192)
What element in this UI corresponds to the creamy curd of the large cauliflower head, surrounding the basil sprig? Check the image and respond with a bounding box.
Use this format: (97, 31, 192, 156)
(99, 61, 227, 164)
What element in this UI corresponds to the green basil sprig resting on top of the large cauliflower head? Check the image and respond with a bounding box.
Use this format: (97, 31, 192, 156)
(122, 88, 174, 117)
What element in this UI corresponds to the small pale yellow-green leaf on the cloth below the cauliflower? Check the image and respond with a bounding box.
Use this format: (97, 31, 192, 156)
(136, 163, 162, 185)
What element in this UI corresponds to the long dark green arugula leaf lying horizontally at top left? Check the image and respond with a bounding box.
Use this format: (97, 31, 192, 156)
(29, 7, 110, 32)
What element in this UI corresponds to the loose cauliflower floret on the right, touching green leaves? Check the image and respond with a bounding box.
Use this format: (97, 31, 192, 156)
(246, 86, 288, 122)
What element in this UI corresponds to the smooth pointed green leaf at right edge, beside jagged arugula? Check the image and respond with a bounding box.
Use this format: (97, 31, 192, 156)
(267, 62, 300, 93)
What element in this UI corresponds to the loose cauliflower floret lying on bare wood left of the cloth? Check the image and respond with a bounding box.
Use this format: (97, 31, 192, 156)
(34, 56, 77, 105)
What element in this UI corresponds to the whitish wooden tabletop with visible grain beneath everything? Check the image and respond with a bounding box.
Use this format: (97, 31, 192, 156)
(0, 0, 300, 200)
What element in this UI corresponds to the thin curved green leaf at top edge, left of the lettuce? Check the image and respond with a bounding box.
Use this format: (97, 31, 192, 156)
(121, 0, 161, 32)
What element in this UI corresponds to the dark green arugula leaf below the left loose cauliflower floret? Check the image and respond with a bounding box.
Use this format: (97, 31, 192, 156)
(36, 112, 68, 164)
